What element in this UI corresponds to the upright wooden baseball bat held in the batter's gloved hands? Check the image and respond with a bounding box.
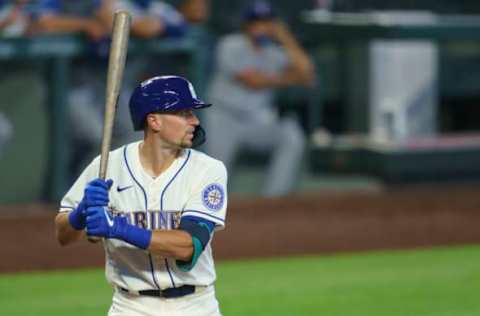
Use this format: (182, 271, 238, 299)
(88, 11, 131, 242)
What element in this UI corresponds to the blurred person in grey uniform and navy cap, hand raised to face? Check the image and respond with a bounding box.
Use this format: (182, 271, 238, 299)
(205, 1, 313, 196)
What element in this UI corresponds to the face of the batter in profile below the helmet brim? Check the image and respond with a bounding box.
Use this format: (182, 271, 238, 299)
(152, 109, 200, 148)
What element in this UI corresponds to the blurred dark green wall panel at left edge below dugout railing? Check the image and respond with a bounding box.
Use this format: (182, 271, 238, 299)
(0, 71, 48, 203)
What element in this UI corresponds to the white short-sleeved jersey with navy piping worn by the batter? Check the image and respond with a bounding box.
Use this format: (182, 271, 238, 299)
(60, 142, 227, 290)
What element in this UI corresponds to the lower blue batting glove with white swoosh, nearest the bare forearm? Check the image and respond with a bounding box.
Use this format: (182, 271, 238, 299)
(86, 206, 152, 249)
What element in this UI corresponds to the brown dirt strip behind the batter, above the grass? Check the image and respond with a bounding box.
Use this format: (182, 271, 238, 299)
(0, 187, 480, 272)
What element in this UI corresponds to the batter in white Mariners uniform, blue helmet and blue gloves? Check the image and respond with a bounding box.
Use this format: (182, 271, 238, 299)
(55, 76, 227, 316)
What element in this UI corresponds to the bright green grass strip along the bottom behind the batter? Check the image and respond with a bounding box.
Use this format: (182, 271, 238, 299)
(0, 246, 480, 316)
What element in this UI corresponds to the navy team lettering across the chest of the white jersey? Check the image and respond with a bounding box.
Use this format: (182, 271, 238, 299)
(111, 209, 182, 230)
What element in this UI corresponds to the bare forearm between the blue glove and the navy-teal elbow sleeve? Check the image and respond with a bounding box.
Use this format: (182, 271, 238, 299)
(148, 230, 193, 261)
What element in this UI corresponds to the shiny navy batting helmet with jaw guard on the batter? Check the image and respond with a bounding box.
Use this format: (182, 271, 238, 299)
(129, 76, 211, 146)
